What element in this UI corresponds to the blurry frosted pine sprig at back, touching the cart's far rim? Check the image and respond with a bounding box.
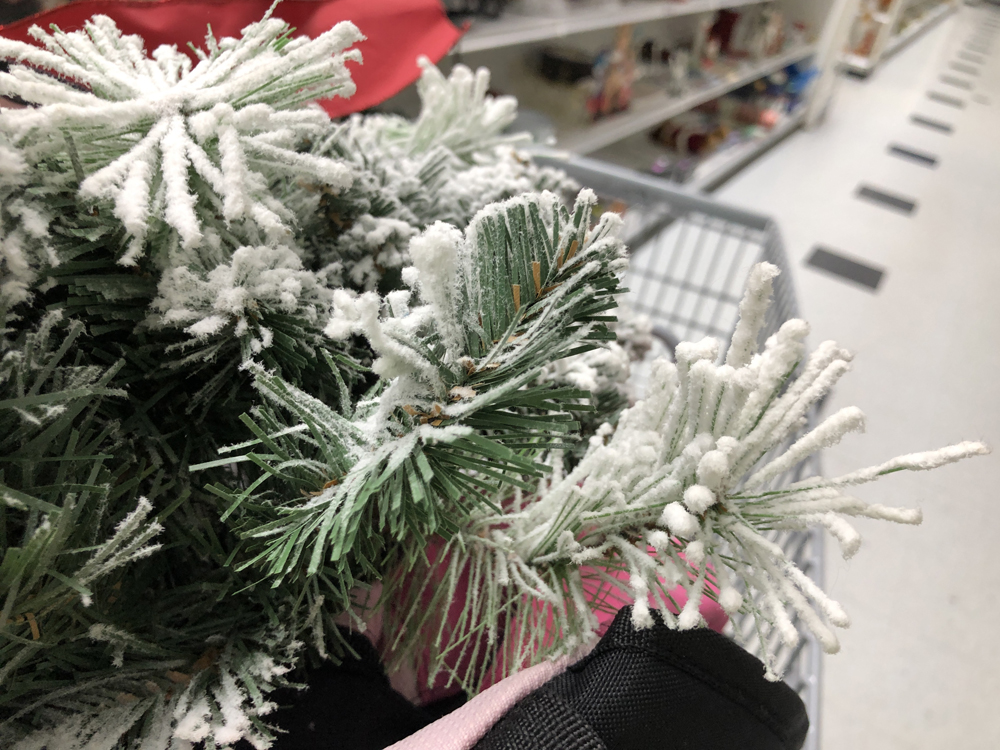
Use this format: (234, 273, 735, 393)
(299, 60, 578, 291)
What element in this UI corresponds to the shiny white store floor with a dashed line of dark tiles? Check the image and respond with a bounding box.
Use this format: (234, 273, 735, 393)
(716, 7, 1000, 750)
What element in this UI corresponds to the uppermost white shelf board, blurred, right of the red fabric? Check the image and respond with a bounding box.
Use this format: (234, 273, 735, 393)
(455, 0, 765, 54)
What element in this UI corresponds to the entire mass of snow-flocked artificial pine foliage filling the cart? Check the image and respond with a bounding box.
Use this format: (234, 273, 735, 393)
(0, 2, 986, 750)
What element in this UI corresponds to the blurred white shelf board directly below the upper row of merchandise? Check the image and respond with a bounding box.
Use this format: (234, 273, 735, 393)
(557, 44, 815, 154)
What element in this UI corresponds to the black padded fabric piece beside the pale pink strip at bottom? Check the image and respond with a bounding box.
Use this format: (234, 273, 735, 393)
(476, 607, 809, 750)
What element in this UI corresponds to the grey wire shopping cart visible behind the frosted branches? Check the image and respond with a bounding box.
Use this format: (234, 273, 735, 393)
(536, 151, 823, 750)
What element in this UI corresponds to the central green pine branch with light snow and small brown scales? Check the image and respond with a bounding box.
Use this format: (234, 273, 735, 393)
(213, 191, 623, 586)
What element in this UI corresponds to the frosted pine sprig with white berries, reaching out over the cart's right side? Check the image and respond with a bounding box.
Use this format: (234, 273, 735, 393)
(387, 264, 989, 684)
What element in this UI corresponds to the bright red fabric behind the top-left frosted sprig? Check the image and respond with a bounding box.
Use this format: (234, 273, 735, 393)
(0, 0, 461, 117)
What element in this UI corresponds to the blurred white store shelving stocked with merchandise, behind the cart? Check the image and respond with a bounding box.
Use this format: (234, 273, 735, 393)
(422, 0, 853, 191)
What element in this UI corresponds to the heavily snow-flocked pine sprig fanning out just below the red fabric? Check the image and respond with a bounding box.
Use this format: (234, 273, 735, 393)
(0, 2, 364, 265)
